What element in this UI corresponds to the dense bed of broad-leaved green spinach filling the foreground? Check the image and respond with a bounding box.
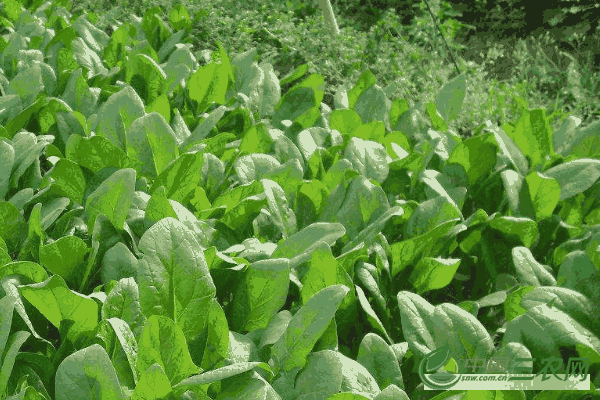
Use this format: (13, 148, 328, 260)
(0, 0, 600, 400)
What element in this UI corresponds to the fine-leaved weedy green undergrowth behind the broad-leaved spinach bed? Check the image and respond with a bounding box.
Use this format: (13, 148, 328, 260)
(72, 0, 600, 137)
